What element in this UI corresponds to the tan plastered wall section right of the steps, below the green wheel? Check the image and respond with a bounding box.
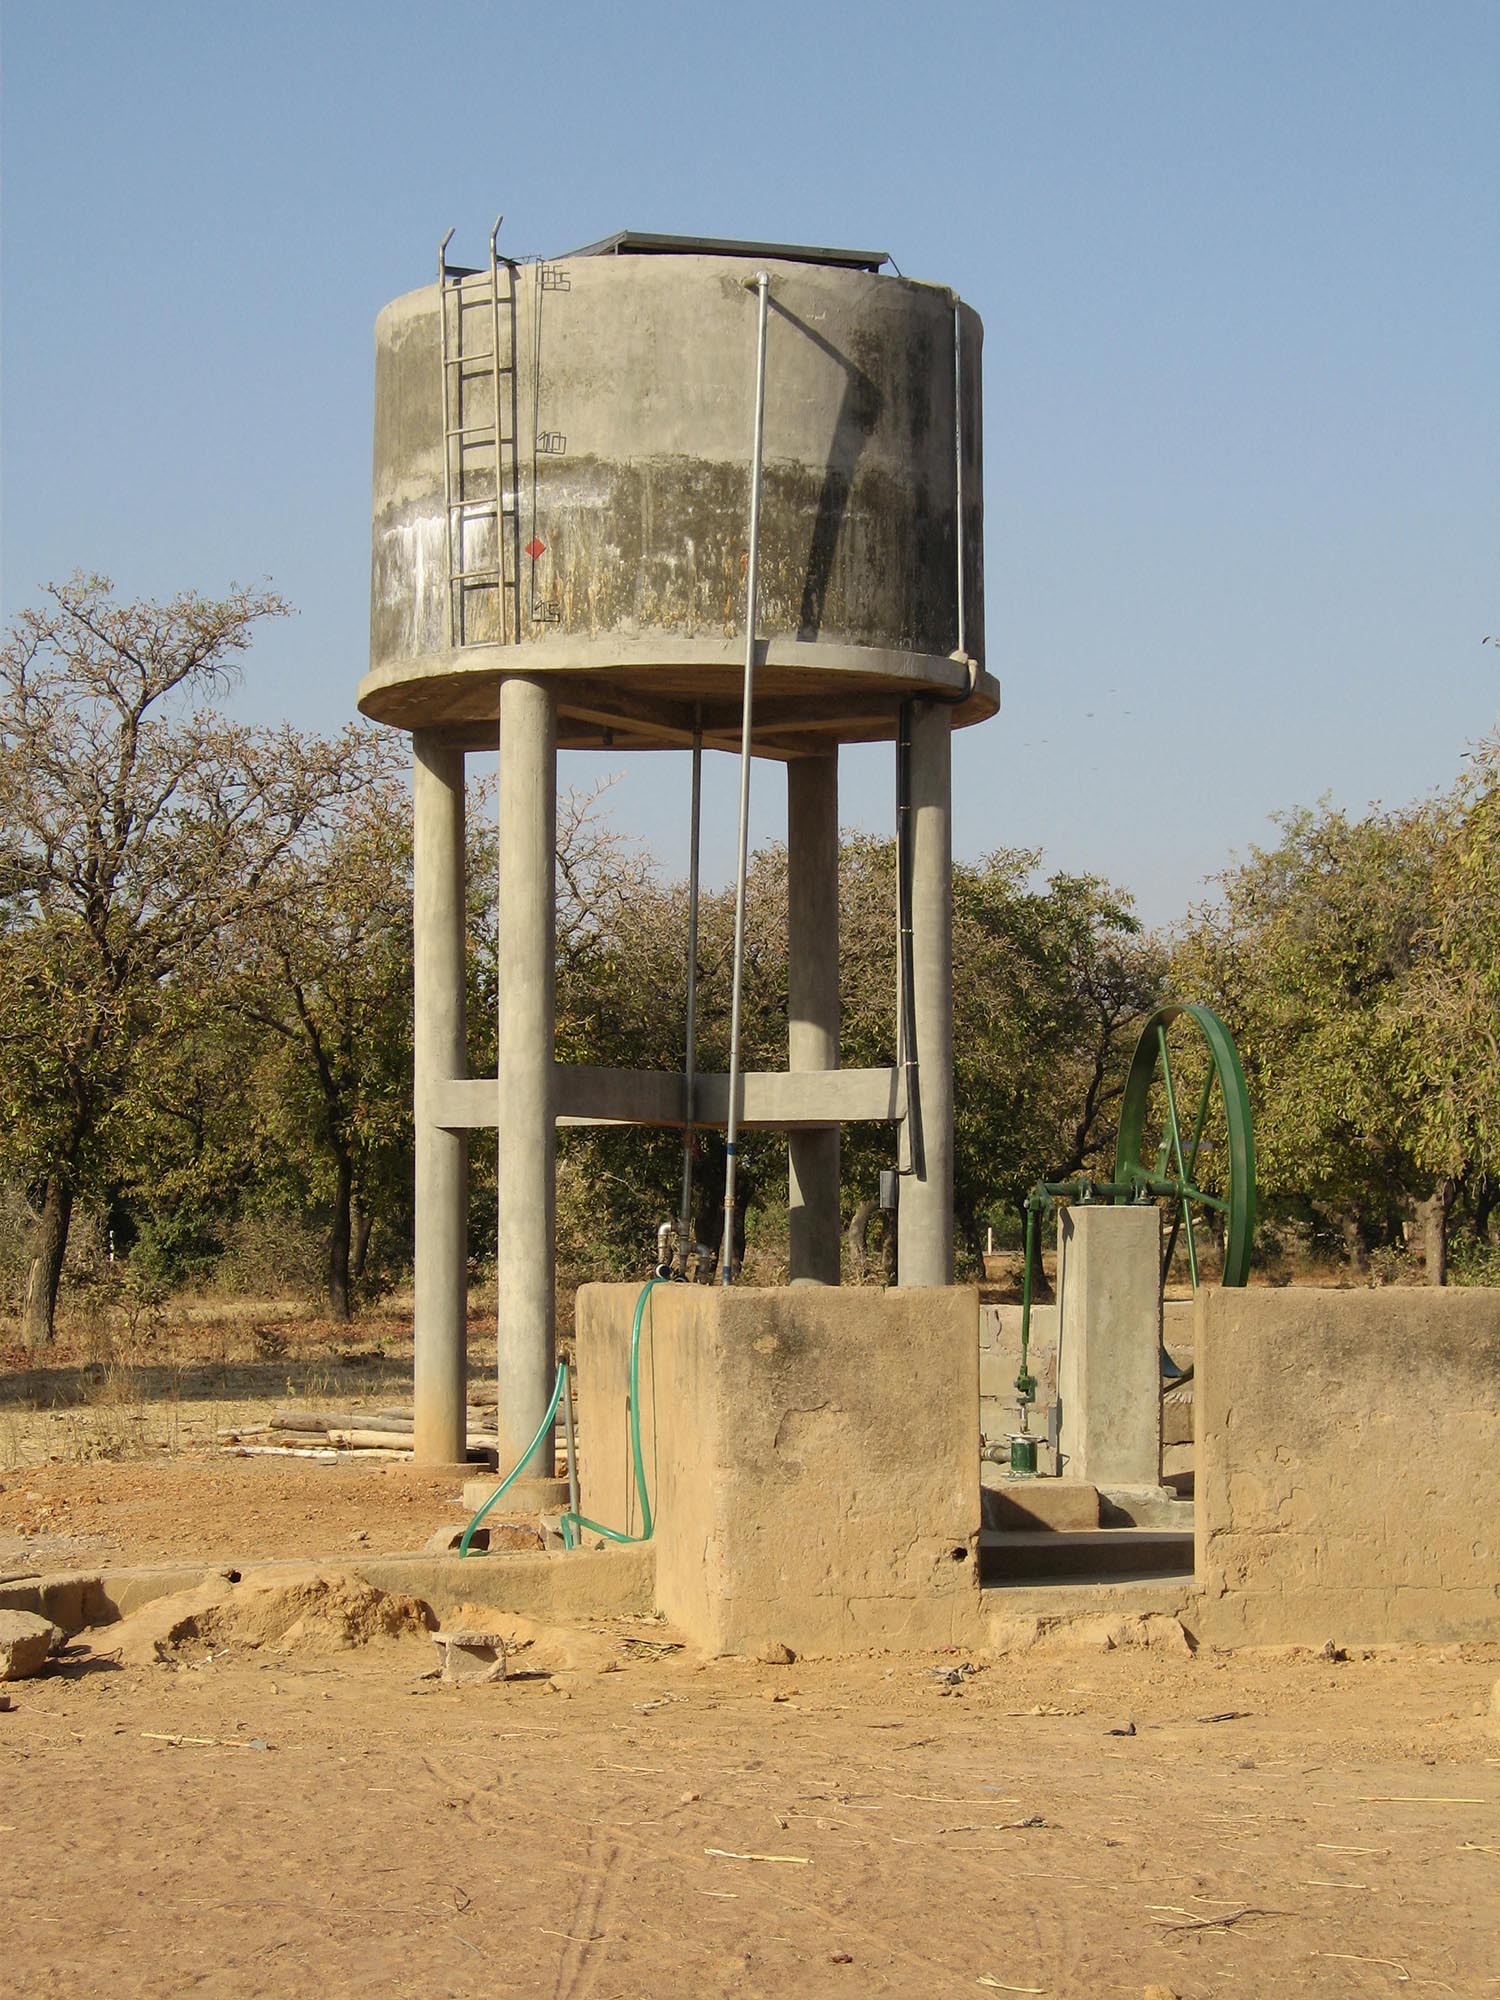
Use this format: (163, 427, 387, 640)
(1194, 1288, 1500, 1646)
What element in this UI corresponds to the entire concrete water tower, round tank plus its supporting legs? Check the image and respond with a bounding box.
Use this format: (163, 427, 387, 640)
(360, 226, 998, 1466)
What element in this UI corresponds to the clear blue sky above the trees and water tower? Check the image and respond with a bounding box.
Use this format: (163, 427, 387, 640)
(0, 0, 1500, 920)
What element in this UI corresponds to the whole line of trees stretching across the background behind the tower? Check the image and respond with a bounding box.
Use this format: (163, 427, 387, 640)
(11, 578, 1500, 1330)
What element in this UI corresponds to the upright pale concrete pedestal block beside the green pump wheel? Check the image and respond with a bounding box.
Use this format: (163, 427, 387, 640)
(1058, 1206, 1162, 1486)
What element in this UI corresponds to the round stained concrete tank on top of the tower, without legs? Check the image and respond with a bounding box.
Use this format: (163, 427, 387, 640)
(360, 236, 998, 756)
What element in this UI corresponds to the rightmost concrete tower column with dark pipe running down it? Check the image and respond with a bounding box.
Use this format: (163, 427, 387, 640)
(896, 702, 954, 1284)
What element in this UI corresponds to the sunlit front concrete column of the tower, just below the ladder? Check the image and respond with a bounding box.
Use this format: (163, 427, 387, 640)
(496, 676, 558, 1480)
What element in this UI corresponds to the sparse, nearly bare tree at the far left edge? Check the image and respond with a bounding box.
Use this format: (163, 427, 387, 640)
(0, 574, 374, 1346)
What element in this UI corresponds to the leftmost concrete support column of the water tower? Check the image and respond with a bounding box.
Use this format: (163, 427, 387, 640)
(412, 730, 468, 1466)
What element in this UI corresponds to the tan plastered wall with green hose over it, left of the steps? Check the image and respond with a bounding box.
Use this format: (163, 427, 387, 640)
(576, 1284, 978, 1652)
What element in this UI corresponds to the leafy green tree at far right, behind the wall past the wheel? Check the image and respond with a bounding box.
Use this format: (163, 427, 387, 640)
(1172, 768, 1500, 1278)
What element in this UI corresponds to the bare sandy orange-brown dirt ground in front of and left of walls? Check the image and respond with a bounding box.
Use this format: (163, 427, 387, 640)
(0, 1304, 1500, 2000)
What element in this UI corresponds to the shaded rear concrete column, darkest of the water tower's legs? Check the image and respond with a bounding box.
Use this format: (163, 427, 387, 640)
(786, 750, 842, 1284)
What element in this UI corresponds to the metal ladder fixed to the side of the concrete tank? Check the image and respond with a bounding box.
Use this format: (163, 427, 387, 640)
(438, 216, 522, 646)
